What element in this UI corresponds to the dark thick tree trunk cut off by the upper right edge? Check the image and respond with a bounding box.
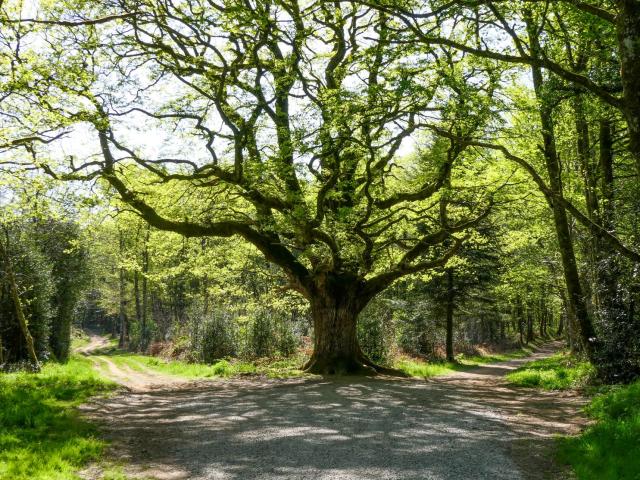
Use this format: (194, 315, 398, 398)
(616, 0, 640, 173)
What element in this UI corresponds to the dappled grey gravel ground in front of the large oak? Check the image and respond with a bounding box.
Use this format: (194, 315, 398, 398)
(79, 346, 583, 480)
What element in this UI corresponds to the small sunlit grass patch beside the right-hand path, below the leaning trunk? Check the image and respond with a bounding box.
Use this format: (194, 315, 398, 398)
(506, 352, 594, 390)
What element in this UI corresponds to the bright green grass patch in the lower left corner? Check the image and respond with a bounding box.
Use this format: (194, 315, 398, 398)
(0, 357, 113, 480)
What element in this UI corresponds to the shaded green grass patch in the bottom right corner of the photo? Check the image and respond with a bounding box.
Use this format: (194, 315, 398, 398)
(558, 381, 640, 480)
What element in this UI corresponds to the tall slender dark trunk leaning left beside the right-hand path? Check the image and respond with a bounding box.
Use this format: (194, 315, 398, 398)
(527, 14, 595, 355)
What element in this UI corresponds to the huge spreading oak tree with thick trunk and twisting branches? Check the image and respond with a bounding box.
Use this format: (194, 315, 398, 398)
(4, 0, 501, 373)
